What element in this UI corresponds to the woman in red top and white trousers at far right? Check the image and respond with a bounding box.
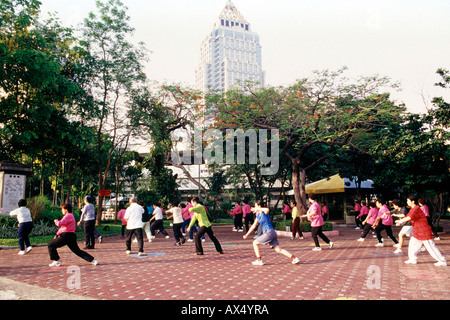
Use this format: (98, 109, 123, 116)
(396, 195, 447, 267)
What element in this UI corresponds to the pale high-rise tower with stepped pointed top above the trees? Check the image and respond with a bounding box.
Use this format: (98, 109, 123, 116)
(195, 0, 265, 93)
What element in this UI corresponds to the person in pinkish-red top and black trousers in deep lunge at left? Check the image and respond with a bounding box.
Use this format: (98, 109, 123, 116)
(48, 203, 98, 267)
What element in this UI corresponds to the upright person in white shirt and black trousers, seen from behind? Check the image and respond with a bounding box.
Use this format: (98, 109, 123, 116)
(124, 197, 144, 255)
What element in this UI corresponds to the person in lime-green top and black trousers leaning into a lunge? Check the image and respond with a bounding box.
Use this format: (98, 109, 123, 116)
(187, 198, 223, 255)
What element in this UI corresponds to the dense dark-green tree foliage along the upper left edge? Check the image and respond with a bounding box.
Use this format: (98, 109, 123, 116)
(0, 0, 78, 159)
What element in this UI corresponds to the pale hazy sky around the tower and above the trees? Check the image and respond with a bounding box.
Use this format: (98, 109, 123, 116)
(40, 0, 450, 113)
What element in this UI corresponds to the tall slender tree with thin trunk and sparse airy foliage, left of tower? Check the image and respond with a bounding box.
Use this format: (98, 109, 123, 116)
(80, 0, 147, 222)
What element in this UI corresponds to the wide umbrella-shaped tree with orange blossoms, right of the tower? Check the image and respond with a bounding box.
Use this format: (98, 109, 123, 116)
(209, 69, 404, 212)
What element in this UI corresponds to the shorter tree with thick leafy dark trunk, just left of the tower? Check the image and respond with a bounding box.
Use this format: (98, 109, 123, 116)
(130, 85, 201, 202)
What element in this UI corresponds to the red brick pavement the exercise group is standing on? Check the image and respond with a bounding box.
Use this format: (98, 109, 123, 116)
(0, 222, 450, 301)
